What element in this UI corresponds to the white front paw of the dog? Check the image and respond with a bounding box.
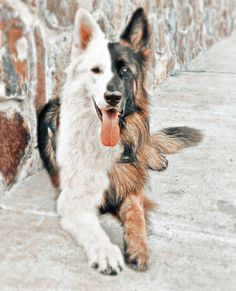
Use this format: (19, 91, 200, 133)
(88, 244, 124, 275)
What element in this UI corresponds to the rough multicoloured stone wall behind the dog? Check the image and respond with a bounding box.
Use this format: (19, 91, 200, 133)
(0, 0, 236, 192)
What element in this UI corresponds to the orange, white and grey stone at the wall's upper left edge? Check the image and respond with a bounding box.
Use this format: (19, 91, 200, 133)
(1, 5, 28, 99)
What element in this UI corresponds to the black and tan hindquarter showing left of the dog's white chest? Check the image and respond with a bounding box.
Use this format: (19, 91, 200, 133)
(38, 98, 60, 188)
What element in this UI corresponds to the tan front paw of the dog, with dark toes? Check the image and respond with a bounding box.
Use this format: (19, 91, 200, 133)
(125, 241, 150, 271)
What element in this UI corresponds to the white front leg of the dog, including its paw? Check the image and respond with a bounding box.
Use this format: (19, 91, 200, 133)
(58, 191, 124, 275)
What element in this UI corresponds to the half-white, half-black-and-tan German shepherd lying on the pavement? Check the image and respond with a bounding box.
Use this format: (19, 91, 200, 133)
(38, 8, 201, 275)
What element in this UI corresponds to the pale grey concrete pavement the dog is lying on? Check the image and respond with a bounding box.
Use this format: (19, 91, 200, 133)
(0, 33, 236, 291)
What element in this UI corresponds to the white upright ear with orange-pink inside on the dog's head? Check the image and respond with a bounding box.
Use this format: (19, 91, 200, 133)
(71, 8, 104, 57)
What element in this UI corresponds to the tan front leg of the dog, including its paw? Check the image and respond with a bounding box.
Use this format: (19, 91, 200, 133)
(119, 192, 149, 271)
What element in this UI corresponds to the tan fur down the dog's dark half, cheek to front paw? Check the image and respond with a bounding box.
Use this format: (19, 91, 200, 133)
(104, 40, 152, 271)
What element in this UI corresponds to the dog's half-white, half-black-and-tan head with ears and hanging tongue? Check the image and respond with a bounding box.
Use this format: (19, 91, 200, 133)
(71, 8, 149, 146)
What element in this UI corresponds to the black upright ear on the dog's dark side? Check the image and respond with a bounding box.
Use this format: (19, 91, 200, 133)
(120, 8, 149, 50)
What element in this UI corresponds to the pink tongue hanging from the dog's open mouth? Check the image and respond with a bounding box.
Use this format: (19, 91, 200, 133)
(101, 109, 120, 147)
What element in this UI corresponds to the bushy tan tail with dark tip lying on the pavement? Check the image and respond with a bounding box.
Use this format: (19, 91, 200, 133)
(151, 126, 203, 155)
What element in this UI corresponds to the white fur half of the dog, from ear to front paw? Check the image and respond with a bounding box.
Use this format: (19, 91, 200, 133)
(57, 9, 123, 273)
